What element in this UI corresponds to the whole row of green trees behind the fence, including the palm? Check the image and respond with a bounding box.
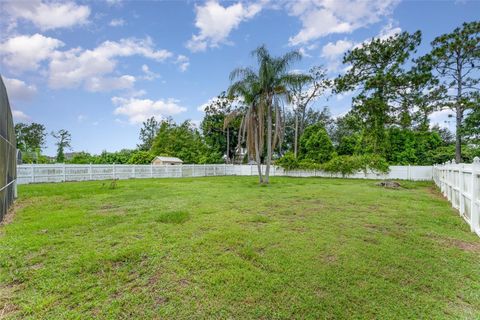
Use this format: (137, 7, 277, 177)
(16, 21, 480, 183)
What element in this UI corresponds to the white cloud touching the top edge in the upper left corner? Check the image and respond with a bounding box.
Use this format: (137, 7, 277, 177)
(3, 0, 90, 31)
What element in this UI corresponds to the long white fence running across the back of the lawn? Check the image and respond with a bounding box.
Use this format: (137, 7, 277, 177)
(17, 164, 433, 184)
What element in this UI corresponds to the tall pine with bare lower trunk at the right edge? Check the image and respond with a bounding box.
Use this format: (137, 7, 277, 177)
(427, 21, 480, 163)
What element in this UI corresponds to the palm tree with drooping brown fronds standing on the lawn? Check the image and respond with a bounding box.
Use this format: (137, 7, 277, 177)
(230, 45, 302, 184)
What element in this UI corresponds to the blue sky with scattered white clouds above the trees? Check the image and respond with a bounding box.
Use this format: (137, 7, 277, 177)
(0, 0, 480, 154)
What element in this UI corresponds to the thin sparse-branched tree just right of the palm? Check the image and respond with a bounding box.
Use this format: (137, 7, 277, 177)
(289, 66, 331, 158)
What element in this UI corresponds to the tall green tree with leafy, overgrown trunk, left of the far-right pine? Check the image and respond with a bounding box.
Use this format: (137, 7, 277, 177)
(336, 31, 421, 155)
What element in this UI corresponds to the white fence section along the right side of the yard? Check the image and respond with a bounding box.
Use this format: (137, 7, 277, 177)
(433, 157, 480, 236)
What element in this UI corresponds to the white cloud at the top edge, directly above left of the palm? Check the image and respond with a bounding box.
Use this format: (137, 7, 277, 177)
(187, 0, 262, 52)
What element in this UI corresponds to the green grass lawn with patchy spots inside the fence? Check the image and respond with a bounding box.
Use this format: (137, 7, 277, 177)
(0, 177, 480, 319)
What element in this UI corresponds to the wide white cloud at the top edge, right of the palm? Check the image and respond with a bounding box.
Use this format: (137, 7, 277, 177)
(287, 0, 399, 45)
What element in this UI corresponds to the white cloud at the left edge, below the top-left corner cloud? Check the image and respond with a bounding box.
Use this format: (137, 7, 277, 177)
(0, 33, 64, 71)
